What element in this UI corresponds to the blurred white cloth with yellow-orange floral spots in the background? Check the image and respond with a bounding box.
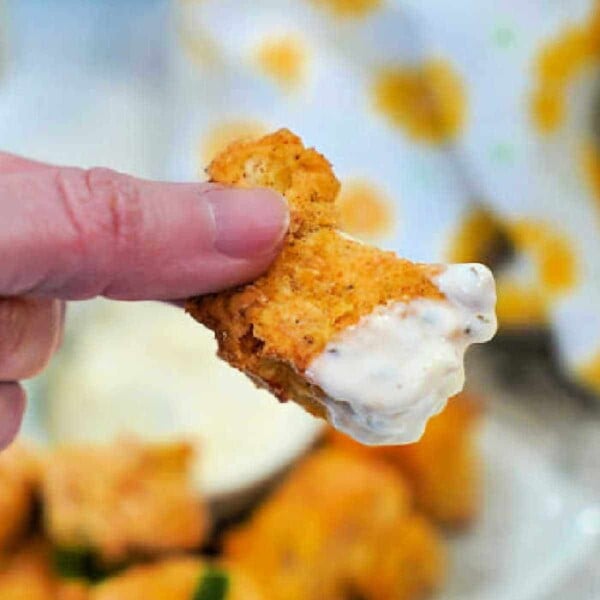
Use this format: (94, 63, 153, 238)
(171, 0, 600, 392)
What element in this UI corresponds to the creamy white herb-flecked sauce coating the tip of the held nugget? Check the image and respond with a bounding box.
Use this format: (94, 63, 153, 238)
(306, 264, 496, 445)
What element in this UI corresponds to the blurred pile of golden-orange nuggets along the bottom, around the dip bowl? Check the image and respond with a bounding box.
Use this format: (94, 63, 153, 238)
(0, 395, 480, 600)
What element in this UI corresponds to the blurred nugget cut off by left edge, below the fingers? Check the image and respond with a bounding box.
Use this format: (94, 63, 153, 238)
(0, 443, 39, 552)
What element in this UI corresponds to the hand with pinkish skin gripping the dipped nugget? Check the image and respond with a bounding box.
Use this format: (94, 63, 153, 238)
(0, 153, 289, 448)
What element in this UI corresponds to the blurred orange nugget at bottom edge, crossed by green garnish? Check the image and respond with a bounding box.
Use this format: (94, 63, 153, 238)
(90, 556, 266, 600)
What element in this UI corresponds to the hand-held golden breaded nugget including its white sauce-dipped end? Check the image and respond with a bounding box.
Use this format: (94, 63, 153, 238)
(187, 130, 496, 444)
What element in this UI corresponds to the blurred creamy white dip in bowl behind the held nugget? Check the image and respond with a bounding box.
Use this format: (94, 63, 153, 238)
(45, 300, 322, 496)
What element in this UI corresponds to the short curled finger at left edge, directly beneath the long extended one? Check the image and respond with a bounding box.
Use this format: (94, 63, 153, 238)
(0, 298, 63, 381)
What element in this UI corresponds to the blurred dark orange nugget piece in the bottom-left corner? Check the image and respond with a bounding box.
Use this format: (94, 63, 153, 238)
(0, 539, 88, 600)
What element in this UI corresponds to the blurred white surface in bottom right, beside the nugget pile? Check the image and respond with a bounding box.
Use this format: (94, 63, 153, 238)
(436, 412, 600, 600)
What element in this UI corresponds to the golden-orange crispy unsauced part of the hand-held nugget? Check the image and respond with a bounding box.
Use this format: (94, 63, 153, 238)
(187, 130, 443, 417)
